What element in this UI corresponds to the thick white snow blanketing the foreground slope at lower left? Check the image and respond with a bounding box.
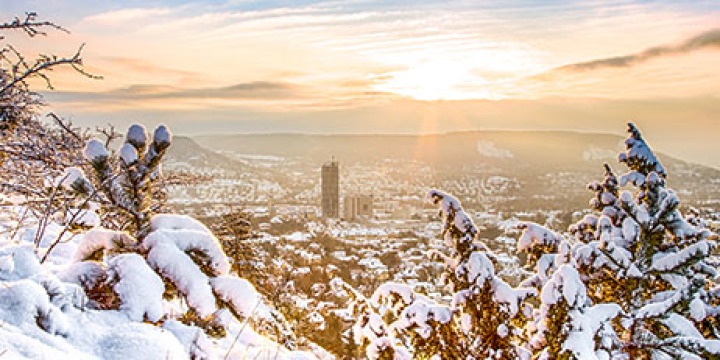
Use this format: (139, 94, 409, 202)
(0, 199, 330, 359)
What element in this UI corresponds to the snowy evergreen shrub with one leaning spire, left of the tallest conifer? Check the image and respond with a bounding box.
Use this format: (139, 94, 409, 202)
(344, 190, 537, 359)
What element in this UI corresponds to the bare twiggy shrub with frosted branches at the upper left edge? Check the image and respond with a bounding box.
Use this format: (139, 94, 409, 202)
(0, 12, 93, 207)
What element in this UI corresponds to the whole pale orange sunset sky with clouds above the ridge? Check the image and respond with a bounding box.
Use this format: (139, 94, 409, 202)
(0, 0, 720, 167)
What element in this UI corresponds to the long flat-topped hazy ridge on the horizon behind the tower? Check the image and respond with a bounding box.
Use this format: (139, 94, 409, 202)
(193, 130, 680, 170)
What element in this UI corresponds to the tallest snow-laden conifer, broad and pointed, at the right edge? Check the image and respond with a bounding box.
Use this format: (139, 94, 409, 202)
(531, 124, 720, 359)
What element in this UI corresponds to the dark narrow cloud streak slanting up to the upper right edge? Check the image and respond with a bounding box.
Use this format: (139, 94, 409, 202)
(551, 29, 720, 71)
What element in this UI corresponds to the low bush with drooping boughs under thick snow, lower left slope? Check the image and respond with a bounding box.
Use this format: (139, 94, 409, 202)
(66, 214, 267, 336)
